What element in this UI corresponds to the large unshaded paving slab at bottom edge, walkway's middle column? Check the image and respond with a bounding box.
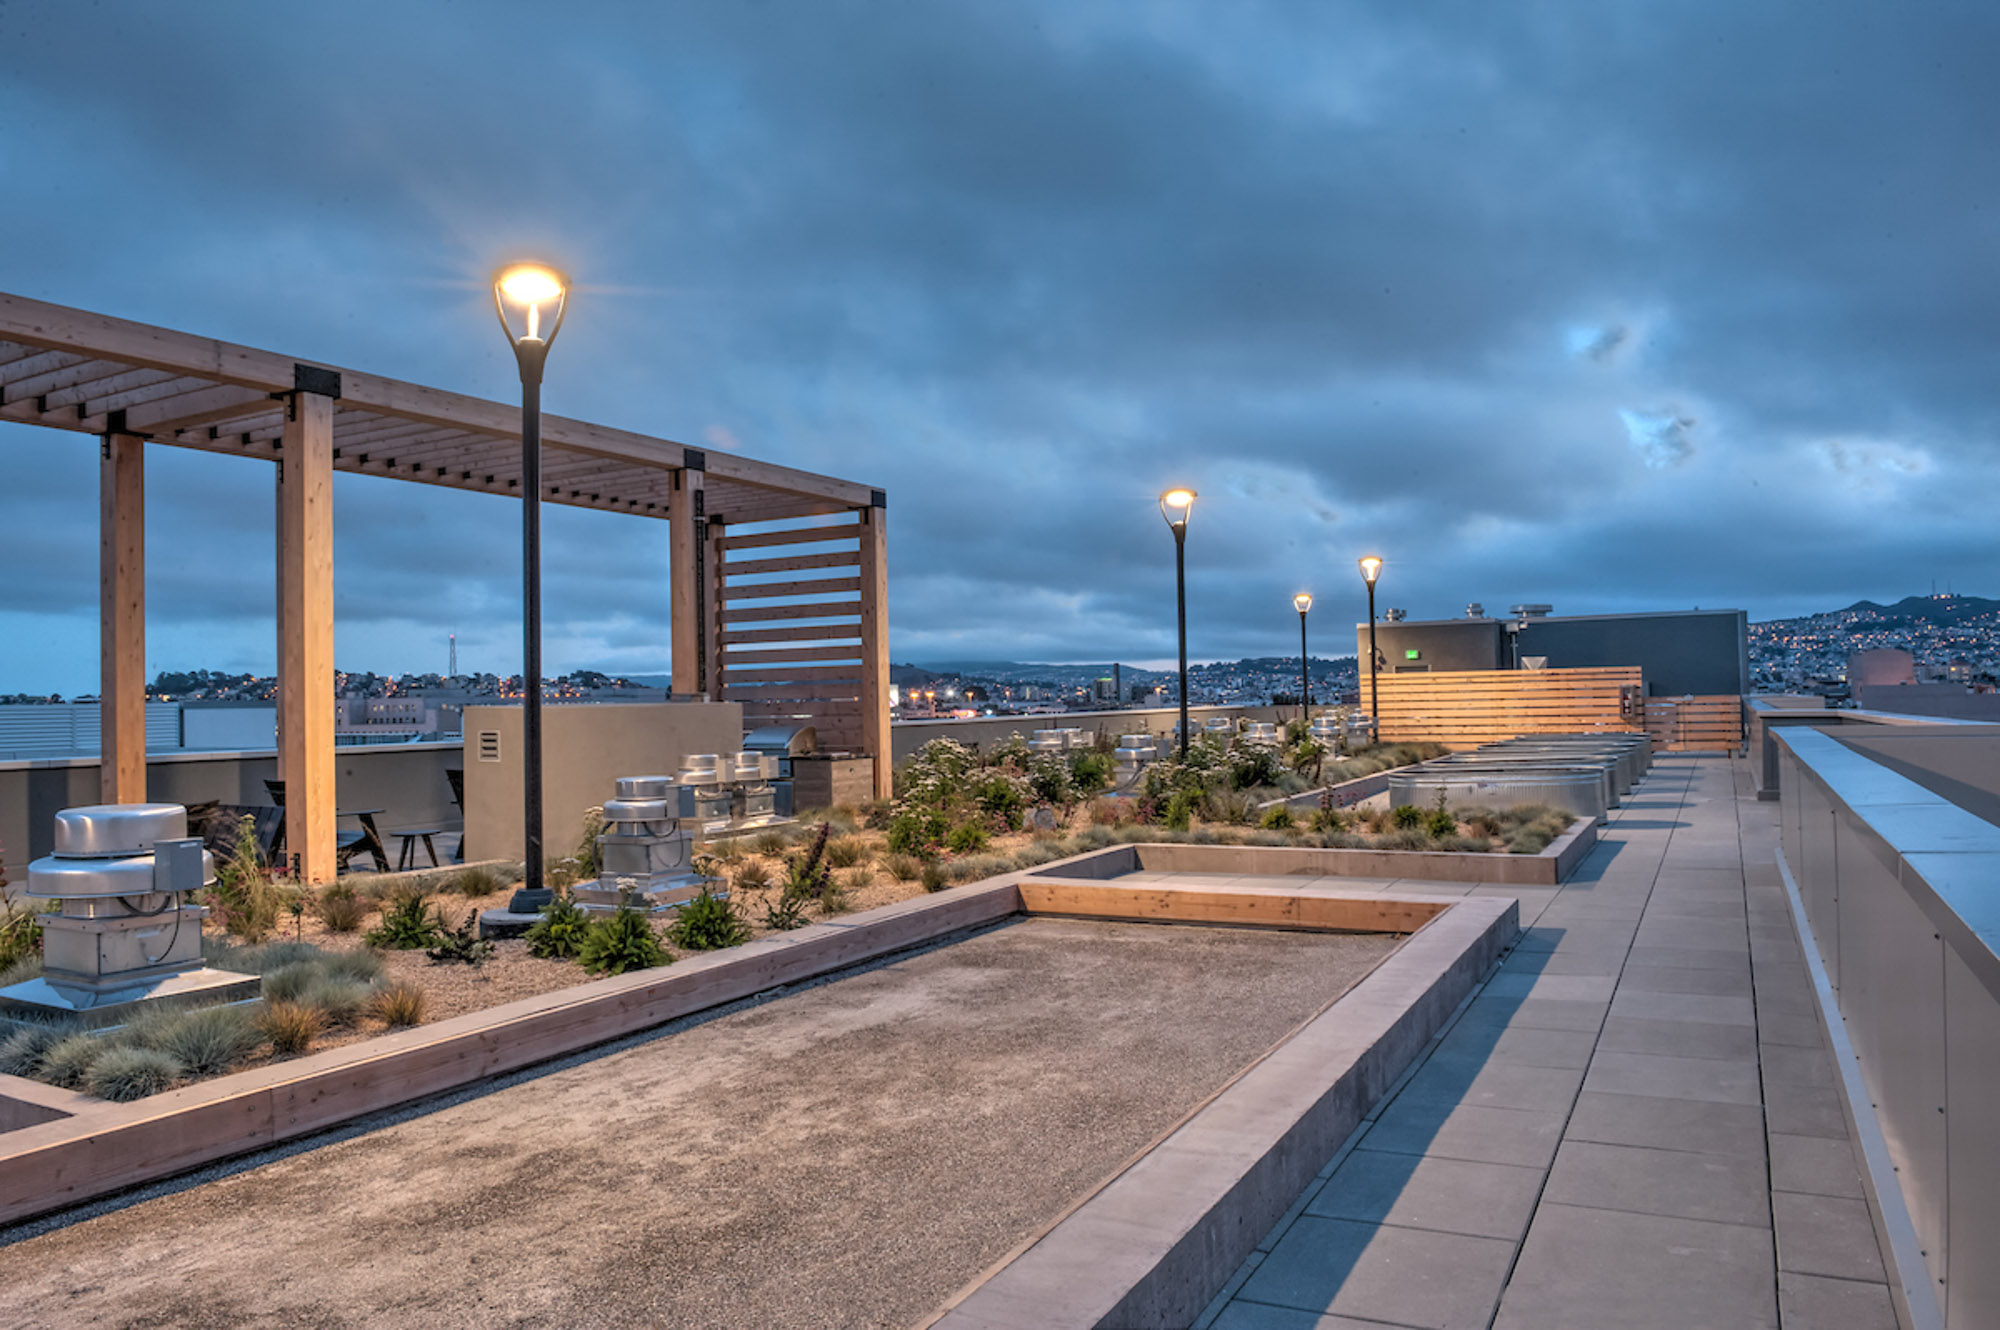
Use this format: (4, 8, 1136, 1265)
(1494, 1202, 1778, 1330)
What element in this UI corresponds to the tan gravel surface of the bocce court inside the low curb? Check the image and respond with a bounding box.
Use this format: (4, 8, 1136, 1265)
(0, 920, 1396, 1328)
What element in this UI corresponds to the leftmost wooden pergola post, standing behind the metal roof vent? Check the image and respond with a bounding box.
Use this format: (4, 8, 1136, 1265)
(98, 432, 146, 804)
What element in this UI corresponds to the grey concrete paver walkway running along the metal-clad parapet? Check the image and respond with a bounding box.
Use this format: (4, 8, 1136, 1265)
(1200, 756, 1896, 1330)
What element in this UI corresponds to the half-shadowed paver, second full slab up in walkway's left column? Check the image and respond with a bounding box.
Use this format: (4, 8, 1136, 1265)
(1306, 1150, 1544, 1242)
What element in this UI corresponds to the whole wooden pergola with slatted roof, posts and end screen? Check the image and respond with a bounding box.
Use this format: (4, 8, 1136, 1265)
(0, 292, 890, 882)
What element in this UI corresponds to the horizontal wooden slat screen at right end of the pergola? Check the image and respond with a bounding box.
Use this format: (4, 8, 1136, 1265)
(716, 514, 862, 752)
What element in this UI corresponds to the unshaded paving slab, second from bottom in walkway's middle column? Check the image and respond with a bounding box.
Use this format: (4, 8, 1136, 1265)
(1544, 1140, 1770, 1228)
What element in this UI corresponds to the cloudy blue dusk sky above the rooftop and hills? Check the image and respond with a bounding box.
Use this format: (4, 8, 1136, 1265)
(0, 0, 2000, 692)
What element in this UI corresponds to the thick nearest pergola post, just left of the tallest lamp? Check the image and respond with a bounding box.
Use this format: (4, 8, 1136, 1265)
(278, 392, 336, 882)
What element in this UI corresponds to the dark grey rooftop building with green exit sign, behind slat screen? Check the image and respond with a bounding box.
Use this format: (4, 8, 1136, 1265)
(1356, 606, 1750, 698)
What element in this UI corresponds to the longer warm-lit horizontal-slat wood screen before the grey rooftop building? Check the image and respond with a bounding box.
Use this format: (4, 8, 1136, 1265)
(1362, 666, 1642, 748)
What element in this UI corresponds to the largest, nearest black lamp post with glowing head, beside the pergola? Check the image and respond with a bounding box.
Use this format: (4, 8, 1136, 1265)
(494, 264, 570, 914)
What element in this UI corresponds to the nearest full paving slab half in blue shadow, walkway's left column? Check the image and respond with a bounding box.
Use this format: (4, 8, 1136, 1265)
(1242, 1216, 1514, 1330)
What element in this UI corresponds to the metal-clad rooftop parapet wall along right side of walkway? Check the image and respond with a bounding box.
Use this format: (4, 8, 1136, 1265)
(1772, 728, 2000, 1326)
